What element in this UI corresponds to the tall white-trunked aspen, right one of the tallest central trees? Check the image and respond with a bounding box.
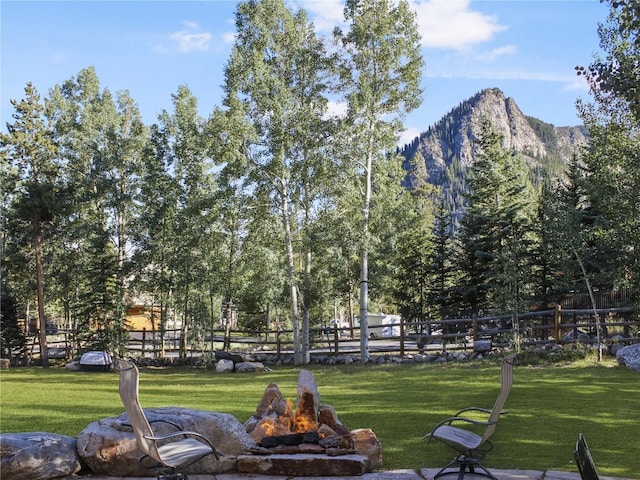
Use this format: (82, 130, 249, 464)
(334, 0, 423, 362)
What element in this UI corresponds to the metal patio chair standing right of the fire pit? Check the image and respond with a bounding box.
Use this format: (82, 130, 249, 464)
(423, 355, 516, 480)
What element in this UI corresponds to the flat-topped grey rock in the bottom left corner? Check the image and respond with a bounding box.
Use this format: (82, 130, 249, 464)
(0, 432, 82, 480)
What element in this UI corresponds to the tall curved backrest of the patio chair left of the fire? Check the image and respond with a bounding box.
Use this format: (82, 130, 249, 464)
(115, 358, 161, 462)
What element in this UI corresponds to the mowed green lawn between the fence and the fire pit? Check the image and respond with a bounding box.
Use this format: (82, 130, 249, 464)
(0, 360, 640, 478)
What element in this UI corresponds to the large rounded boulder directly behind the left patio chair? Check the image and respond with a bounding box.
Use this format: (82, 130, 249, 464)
(77, 407, 256, 477)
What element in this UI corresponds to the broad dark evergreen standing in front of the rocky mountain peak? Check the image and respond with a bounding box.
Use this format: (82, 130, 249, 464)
(461, 121, 538, 330)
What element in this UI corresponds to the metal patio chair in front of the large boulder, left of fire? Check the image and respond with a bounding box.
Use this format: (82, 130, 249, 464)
(115, 358, 218, 480)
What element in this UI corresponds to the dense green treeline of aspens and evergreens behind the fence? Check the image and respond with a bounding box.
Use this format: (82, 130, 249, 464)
(0, 0, 640, 366)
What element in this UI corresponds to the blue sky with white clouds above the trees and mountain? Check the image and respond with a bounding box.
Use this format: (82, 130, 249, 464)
(0, 0, 609, 145)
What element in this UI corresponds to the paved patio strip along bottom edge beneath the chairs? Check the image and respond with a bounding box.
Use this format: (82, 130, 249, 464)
(62, 468, 626, 480)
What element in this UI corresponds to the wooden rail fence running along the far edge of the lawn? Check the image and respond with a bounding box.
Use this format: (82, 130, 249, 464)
(28, 305, 640, 358)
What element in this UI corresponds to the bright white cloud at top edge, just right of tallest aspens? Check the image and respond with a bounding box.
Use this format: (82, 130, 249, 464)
(410, 0, 506, 50)
